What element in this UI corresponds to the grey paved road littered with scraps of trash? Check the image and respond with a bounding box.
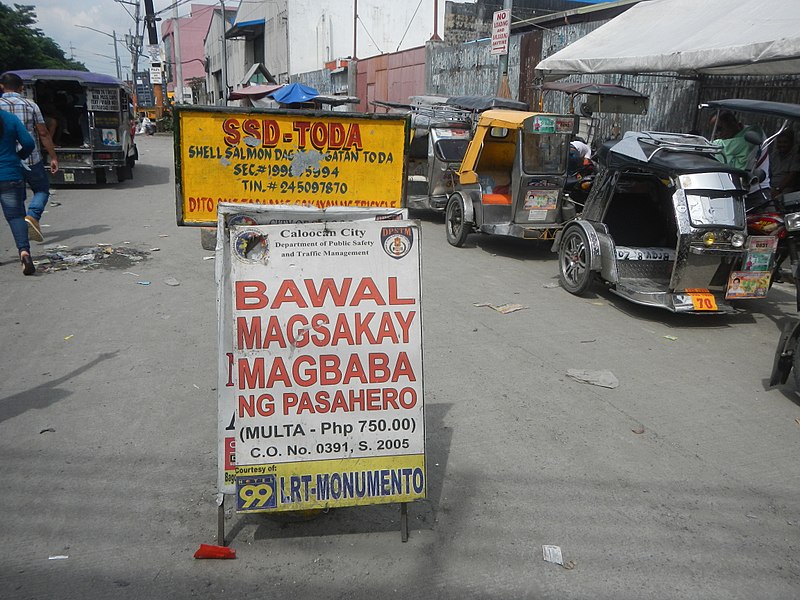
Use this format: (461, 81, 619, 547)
(0, 136, 800, 600)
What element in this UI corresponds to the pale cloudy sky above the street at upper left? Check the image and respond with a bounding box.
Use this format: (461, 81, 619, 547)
(23, 0, 200, 78)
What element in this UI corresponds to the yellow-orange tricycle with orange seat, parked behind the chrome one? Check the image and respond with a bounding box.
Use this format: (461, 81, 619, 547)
(445, 110, 578, 247)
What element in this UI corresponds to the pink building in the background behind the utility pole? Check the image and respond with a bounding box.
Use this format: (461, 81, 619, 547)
(161, 4, 216, 102)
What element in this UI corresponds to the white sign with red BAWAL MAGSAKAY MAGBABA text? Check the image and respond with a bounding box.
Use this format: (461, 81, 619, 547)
(230, 221, 427, 512)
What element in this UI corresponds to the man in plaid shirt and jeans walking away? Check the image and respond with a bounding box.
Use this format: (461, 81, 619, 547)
(0, 73, 58, 242)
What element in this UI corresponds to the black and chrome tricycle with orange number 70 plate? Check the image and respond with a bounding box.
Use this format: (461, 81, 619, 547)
(553, 132, 769, 313)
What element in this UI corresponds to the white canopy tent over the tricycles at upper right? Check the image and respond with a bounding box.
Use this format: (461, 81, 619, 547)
(536, 0, 800, 80)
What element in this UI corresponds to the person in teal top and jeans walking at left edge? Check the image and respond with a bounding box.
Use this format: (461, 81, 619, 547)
(0, 110, 36, 275)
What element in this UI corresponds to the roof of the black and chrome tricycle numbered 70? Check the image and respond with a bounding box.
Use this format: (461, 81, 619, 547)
(597, 131, 745, 176)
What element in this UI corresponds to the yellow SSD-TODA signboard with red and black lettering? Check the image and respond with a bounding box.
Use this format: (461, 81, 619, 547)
(175, 107, 409, 225)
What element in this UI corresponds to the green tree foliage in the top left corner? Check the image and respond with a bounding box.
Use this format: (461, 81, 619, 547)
(0, 2, 88, 73)
